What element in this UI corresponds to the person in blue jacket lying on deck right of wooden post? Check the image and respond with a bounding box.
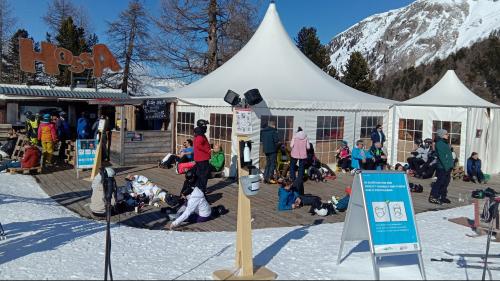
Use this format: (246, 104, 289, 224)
(278, 179, 336, 216)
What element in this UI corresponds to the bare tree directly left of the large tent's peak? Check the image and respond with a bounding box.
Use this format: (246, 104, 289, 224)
(155, 0, 258, 77)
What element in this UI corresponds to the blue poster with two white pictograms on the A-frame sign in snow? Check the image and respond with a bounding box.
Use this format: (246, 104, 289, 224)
(361, 173, 420, 254)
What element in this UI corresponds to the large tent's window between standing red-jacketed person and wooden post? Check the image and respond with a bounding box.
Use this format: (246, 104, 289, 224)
(209, 113, 233, 167)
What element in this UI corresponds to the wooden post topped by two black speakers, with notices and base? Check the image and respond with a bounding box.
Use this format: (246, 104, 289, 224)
(213, 89, 277, 280)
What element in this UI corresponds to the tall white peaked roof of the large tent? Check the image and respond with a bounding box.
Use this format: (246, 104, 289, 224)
(160, 3, 395, 110)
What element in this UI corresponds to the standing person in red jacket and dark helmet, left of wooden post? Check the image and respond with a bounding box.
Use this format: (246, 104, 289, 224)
(193, 119, 211, 193)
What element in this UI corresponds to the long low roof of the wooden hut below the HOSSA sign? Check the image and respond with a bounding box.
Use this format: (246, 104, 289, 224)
(0, 84, 128, 99)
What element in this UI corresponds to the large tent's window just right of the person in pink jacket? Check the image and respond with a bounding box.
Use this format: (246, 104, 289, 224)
(314, 116, 344, 164)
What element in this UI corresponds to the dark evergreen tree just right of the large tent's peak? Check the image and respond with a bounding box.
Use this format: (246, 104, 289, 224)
(295, 27, 337, 73)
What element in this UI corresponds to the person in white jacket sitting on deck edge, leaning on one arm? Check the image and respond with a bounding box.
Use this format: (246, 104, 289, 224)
(168, 187, 212, 230)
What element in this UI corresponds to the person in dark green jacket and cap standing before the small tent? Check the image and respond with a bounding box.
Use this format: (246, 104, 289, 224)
(429, 129, 453, 204)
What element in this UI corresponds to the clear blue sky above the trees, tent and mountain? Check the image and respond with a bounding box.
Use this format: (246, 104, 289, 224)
(9, 0, 414, 44)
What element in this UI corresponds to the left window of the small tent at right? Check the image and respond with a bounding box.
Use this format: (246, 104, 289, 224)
(397, 119, 424, 162)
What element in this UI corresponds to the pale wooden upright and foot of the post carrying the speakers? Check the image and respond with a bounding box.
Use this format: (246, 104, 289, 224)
(212, 109, 277, 280)
